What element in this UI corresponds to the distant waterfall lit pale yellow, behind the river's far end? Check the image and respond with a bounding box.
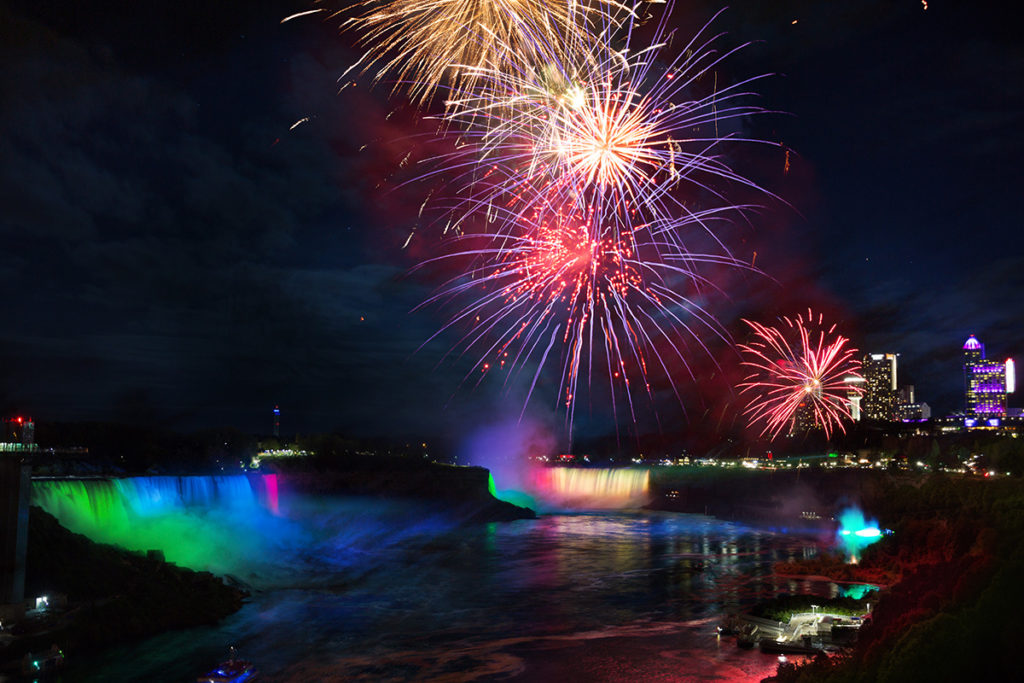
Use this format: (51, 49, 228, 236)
(532, 467, 650, 509)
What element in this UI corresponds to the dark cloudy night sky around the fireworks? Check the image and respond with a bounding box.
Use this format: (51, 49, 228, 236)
(0, 0, 1024, 444)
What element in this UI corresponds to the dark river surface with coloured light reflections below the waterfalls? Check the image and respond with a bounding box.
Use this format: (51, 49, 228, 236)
(73, 512, 835, 682)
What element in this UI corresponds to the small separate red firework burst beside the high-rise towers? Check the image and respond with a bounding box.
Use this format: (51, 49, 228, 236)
(739, 309, 861, 437)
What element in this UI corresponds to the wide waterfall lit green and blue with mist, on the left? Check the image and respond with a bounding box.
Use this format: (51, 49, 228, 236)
(32, 474, 468, 588)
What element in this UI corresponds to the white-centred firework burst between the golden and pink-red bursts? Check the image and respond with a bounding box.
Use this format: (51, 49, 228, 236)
(436, 6, 764, 242)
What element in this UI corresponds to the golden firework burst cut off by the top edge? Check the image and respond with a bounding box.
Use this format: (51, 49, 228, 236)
(342, 0, 621, 102)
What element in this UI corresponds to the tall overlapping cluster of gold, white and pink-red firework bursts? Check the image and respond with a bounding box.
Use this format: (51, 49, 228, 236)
(331, 0, 778, 426)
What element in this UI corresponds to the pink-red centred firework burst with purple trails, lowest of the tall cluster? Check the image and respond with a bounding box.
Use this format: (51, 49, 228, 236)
(417, 193, 745, 424)
